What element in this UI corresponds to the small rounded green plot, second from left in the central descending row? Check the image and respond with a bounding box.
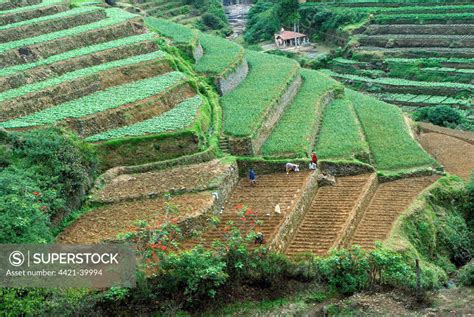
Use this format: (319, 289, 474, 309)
(195, 33, 244, 76)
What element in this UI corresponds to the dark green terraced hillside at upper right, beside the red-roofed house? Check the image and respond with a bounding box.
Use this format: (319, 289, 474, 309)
(325, 1, 474, 114)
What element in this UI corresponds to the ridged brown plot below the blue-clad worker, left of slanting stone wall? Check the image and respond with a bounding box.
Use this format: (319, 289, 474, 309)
(183, 172, 311, 248)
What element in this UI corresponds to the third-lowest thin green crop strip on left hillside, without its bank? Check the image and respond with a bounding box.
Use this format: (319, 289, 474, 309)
(0, 51, 166, 102)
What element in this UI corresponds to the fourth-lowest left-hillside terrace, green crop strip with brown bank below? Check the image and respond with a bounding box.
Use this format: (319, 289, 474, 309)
(0, 33, 158, 92)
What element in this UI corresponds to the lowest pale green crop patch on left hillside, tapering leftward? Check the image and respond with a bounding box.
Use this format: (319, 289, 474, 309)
(86, 96, 203, 142)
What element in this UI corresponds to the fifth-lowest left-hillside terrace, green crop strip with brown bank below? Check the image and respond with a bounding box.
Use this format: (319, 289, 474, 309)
(0, 9, 146, 67)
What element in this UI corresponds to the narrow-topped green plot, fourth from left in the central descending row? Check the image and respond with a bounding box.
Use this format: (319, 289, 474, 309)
(262, 70, 342, 157)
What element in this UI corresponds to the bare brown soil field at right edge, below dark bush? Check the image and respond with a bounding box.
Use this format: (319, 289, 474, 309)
(418, 132, 474, 180)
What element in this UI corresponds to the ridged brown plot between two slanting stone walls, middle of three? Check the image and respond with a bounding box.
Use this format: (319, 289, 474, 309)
(285, 174, 375, 256)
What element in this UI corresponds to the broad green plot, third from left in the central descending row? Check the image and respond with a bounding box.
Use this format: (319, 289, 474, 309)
(221, 51, 299, 136)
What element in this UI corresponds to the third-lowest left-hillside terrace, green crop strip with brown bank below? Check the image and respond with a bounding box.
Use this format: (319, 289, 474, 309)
(0, 51, 171, 121)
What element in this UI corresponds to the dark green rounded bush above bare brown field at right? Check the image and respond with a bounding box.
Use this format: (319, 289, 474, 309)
(413, 105, 465, 127)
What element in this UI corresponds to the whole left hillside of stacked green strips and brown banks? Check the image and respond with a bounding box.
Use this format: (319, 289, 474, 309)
(0, 0, 210, 168)
